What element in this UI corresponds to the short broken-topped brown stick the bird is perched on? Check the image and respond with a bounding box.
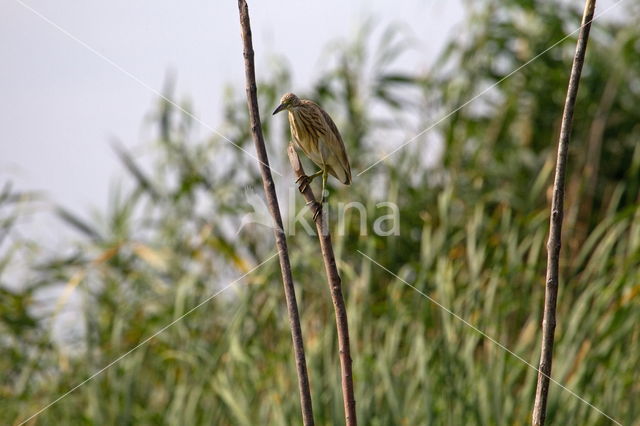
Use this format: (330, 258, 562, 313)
(287, 144, 358, 426)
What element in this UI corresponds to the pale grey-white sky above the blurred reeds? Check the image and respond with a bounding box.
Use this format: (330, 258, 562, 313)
(0, 0, 463, 220)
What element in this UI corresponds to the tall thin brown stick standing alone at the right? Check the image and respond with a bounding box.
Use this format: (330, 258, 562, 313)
(532, 0, 596, 426)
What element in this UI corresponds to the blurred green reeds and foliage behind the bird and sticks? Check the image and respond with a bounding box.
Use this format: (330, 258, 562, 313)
(0, 0, 640, 425)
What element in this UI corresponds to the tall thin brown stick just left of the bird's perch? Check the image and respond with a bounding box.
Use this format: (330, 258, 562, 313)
(238, 0, 314, 426)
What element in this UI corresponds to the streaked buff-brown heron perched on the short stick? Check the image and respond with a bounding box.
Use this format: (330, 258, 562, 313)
(273, 93, 351, 220)
